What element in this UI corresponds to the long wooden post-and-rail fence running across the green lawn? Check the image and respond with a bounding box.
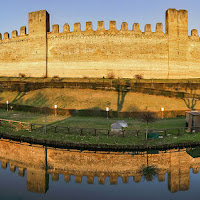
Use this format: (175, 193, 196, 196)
(0, 119, 200, 139)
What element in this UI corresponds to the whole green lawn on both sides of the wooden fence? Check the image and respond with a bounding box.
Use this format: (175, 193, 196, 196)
(0, 110, 200, 146)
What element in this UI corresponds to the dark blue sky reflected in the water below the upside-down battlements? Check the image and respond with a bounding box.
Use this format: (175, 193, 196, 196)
(0, 165, 200, 200)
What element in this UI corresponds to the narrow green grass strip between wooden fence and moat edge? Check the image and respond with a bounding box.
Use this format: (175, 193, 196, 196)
(0, 121, 200, 146)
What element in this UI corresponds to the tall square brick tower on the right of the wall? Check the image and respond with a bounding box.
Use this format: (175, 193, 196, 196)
(166, 9, 189, 77)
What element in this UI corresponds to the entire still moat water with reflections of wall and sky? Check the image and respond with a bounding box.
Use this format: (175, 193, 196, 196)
(0, 140, 200, 200)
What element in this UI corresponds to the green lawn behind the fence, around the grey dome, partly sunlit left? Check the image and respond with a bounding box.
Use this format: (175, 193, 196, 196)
(0, 109, 185, 129)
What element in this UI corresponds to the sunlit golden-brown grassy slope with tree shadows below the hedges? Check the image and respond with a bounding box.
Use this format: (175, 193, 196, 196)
(0, 88, 197, 112)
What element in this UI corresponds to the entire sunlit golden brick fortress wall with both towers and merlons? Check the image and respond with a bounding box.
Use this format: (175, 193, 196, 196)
(0, 9, 200, 78)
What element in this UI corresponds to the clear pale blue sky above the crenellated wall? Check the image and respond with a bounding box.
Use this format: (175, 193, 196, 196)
(0, 0, 200, 35)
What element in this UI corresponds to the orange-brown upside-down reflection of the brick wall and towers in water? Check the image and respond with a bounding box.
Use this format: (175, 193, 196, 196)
(0, 139, 200, 193)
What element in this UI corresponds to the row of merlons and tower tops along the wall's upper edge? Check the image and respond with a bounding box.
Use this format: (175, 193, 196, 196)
(0, 9, 198, 40)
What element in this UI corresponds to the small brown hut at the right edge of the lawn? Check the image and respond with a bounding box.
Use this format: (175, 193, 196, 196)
(185, 110, 200, 132)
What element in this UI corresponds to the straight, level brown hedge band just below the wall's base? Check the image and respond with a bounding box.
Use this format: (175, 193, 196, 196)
(0, 80, 200, 92)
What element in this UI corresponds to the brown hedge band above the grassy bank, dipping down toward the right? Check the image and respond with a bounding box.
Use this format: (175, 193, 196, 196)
(0, 81, 200, 99)
